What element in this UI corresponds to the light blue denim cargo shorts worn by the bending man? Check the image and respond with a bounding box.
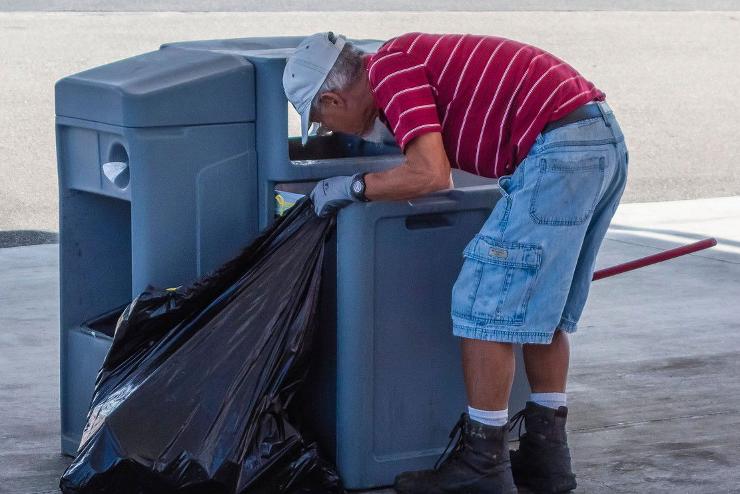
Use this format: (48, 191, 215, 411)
(452, 103, 628, 344)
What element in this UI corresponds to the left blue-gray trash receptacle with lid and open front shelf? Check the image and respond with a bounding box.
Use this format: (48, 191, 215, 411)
(55, 49, 258, 454)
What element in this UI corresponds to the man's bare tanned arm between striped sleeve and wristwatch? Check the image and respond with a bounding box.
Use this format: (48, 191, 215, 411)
(365, 132, 452, 201)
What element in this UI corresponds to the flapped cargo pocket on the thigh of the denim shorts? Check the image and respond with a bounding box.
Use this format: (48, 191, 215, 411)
(452, 235, 542, 326)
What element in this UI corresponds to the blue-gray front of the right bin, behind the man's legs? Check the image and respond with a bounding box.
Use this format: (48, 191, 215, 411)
(330, 185, 527, 489)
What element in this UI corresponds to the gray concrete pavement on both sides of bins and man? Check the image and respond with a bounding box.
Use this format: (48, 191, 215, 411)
(0, 197, 740, 494)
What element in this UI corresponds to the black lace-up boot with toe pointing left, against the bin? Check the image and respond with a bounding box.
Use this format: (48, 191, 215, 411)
(394, 413, 516, 494)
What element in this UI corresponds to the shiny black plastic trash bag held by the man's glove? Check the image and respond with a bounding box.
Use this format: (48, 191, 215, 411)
(60, 200, 343, 494)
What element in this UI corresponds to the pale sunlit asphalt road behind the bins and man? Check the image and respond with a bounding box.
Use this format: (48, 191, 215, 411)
(0, 9, 740, 238)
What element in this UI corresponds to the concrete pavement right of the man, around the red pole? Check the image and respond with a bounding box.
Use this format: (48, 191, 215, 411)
(569, 198, 740, 493)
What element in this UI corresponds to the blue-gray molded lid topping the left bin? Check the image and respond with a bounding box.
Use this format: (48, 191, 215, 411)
(55, 47, 255, 127)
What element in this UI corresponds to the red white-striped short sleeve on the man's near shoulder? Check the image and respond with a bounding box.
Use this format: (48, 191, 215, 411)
(367, 51, 442, 151)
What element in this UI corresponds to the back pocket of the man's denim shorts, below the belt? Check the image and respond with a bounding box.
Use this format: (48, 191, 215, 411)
(529, 157, 605, 226)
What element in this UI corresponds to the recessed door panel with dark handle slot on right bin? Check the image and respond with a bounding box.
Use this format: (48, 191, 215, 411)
(372, 210, 468, 461)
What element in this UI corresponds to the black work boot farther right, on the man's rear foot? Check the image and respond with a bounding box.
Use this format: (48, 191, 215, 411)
(510, 401, 576, 493)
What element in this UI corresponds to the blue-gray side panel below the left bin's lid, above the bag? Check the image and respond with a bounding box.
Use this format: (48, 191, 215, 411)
(127, 124, 258, 295)
